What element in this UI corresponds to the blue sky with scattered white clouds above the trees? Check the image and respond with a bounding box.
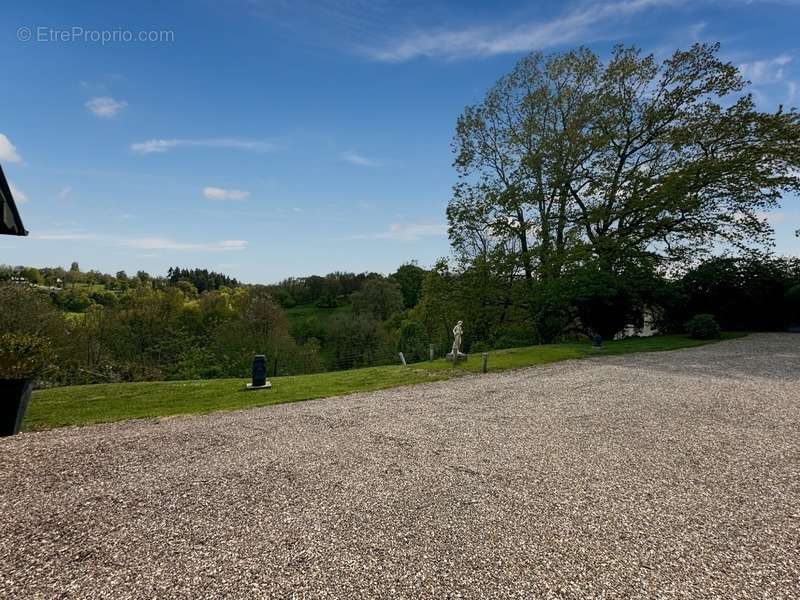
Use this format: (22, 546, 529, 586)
(0, 0, 800, 282)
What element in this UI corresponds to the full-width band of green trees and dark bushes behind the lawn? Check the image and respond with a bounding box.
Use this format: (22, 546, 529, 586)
(0, 251, 800, 385)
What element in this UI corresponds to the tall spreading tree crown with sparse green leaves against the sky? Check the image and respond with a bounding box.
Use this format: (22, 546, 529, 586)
(448, 44, 800, 283)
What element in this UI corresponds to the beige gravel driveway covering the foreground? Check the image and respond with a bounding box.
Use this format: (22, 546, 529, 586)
(0, 334, 800, 599)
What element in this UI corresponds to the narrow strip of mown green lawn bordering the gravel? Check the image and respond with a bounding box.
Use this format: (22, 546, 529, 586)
(24, 334, 743, 431)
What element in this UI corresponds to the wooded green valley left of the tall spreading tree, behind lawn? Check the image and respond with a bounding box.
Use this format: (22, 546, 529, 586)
(0, 263, 425, 384)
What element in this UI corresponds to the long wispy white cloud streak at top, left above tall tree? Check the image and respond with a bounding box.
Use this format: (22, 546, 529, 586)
(366, 0, 681, 62)
